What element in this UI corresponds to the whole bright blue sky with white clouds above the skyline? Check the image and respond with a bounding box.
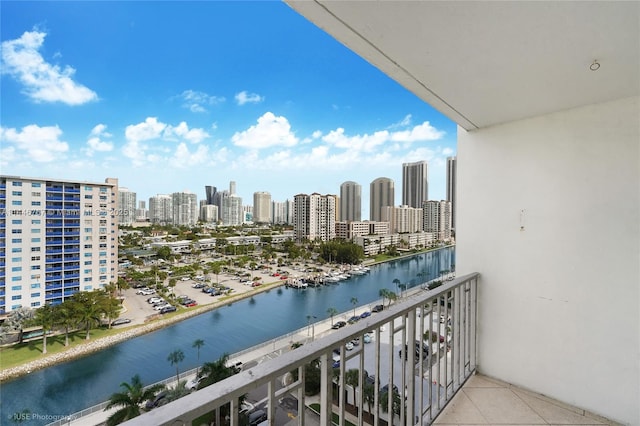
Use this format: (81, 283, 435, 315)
(0, 1, 456, 219)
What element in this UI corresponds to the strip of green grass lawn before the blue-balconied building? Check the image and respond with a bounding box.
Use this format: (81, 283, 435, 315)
(0, 327, 128, 369)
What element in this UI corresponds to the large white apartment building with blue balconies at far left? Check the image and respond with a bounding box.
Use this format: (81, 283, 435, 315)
(0, 176, 119, 314)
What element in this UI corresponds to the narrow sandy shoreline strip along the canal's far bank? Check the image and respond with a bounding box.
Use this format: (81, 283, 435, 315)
(0, 281, 284, 382)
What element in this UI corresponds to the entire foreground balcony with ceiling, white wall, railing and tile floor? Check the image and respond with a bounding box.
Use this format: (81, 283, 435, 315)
(124, 0, 640, 425)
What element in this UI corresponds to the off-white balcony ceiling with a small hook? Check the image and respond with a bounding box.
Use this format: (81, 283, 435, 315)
(287, 0, 640, 130)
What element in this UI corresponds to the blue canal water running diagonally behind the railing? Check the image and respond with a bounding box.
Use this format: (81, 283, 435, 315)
(0, 247, 455, 425)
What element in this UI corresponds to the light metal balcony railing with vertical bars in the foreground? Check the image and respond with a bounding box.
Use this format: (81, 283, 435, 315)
(126, 273, 478, 426)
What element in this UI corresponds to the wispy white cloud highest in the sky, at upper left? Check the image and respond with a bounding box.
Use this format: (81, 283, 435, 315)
(2, 31, 98, 105)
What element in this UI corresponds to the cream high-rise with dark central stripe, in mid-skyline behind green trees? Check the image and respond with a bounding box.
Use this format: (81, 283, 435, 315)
(294, 193, 336, 241)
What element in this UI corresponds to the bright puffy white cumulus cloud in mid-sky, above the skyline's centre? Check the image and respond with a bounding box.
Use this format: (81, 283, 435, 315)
(231, 112, 298, 149)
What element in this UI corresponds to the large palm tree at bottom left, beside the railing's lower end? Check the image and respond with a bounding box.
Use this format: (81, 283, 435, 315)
(104, 374, 164, 426)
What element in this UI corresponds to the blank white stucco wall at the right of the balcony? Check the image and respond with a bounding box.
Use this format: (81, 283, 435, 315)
(456, 97, 640, 425)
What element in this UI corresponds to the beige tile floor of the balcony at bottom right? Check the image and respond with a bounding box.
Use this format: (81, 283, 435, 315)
(434, 375, 616, 426)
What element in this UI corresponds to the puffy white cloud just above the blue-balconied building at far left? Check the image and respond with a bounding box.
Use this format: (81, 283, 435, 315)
(0, 124, 69, 163)
